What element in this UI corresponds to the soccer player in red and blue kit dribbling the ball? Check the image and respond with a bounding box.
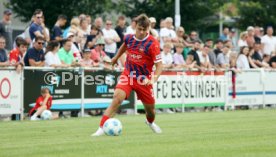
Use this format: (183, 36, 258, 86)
(92, 14, 162, 136)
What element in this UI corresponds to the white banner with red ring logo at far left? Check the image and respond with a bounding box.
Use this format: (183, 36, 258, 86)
(0, 70, 22, 114)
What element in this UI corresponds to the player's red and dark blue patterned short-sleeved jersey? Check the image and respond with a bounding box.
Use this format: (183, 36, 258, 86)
(123, 34, 162, 79)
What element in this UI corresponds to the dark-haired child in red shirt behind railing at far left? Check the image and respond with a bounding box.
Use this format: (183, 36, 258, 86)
(10, 37, 28, 72)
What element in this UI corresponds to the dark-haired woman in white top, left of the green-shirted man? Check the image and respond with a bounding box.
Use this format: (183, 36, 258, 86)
(45, 41, 68, 68)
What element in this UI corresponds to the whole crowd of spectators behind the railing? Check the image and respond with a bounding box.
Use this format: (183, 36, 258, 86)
(0, 9, 276, 71)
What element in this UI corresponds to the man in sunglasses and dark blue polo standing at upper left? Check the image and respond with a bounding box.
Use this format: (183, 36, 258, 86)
(29, 9, 47, 40)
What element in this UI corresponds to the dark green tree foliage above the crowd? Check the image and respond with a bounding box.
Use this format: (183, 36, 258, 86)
(6, 0, 276, 31)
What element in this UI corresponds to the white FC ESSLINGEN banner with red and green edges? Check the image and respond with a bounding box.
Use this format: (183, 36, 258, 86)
(137, 72, 226, 109)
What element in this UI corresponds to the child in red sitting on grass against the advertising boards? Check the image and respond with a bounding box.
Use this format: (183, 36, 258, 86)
(29, 88, 58, 120)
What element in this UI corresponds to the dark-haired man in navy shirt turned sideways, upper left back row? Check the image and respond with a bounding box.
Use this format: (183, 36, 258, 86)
(51, 15, 67, 42)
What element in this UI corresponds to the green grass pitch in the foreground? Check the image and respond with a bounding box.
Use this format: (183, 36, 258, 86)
(0, 110, 276, 157)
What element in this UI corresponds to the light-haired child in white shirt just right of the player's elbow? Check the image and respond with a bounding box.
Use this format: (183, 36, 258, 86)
(161, 43, 173, 68)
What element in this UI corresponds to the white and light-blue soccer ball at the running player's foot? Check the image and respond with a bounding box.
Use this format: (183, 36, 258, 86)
(103, 118, 123, 136)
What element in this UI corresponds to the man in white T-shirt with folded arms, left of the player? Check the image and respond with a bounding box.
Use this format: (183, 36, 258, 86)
(103, 20, 121, 59)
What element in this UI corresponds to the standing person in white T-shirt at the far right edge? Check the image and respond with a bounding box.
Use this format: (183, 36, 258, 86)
(261, 26, 276, 55)
